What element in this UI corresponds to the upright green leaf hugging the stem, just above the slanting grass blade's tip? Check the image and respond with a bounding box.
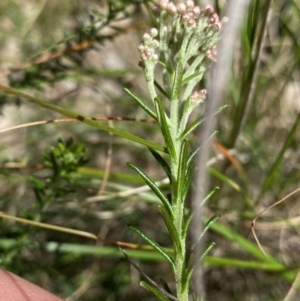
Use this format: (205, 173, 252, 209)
(154, 97, 176, 160)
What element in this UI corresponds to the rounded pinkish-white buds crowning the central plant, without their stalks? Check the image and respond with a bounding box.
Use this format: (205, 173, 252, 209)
(138, 0, 222, 62)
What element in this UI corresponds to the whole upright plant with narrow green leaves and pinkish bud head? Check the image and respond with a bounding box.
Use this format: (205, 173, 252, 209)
(125, 0, 222, 301)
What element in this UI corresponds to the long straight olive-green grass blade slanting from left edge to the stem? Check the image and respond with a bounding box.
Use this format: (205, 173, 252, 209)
(0, 85, 167, 153)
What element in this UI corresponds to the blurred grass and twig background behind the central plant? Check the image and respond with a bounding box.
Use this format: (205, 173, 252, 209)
(0, 0, 300, 301)
